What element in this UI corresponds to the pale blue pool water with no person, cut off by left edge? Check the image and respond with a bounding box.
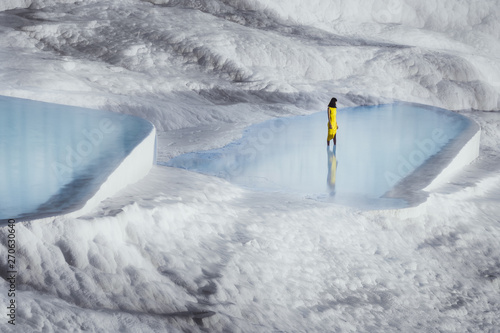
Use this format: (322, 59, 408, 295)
(0, 96, 153, 220)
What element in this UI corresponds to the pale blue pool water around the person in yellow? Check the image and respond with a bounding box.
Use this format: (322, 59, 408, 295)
(167, 103, 470, 208)
